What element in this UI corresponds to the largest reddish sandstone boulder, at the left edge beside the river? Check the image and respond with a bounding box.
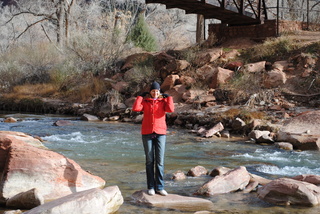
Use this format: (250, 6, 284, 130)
(0, 133, 105, 203)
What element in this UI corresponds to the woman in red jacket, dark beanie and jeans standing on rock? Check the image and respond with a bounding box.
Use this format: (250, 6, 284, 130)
(132, 82, 174, 196)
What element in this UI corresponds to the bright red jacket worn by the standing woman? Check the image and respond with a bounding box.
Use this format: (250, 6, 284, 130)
(132, 96, 174, 135)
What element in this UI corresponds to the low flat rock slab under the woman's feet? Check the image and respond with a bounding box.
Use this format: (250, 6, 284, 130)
(132, 190, 213, 212)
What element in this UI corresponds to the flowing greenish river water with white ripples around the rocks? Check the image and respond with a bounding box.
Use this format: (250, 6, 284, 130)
(0, 113, 320, 214)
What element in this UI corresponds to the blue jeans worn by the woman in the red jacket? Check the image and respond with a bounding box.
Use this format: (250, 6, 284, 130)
(142, 134, 166, 191)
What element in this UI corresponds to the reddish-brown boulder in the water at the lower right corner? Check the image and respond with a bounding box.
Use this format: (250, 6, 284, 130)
(258, 178, 320, 206)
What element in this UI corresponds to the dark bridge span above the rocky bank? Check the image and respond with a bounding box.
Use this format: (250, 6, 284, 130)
(145, 0, 267, 26)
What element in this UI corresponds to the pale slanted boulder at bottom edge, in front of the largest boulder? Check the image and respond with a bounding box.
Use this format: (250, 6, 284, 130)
(24, 186, 123, 214)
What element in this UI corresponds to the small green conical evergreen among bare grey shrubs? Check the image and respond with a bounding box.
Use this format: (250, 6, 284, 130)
(128, 14, 157, 51)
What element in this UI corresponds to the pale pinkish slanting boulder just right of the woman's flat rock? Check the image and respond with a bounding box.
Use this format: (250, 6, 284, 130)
(196, 166, 250, 195)
